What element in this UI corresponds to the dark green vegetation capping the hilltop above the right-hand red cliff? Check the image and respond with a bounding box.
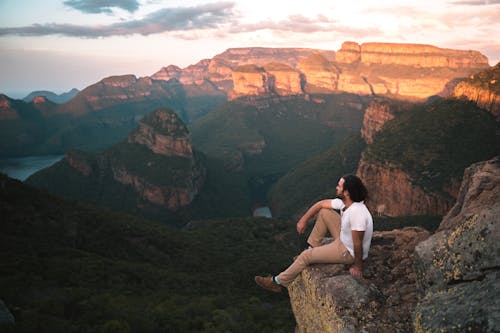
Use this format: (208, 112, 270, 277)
(365, 99, 500, 191)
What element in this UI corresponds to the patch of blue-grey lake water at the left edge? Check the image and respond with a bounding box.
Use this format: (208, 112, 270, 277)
(0, 155, 64, 181)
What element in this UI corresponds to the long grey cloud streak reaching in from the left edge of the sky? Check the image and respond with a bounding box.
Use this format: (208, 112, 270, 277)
(0, 2, 234, 38)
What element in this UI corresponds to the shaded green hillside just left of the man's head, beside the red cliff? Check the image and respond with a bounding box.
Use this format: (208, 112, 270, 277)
(269, 135, 365, 218)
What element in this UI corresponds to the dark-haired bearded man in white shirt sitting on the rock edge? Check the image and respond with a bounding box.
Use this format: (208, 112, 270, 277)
(255, 175, 373, 292)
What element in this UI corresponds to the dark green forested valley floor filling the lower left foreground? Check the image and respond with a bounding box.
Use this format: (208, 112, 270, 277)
(0, 175, 298, 332)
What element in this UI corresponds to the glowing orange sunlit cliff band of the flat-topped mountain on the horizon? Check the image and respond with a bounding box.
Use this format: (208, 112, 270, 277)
(223, 42, 489, 99)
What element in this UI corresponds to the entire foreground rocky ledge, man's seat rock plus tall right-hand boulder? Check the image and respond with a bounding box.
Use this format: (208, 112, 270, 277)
(288, 157, 500, 332)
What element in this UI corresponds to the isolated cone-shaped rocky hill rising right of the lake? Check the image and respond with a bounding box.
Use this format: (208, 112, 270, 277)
(28, 109, 206, 212)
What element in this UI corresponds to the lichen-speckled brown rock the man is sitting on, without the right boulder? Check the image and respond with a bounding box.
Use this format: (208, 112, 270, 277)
(288, 228, 429, 332)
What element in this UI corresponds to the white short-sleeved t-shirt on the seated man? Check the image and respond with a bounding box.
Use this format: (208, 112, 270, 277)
(332, 199, 373, 259)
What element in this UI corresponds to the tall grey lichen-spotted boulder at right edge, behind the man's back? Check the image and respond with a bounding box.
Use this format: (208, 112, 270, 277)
(414, 157, 500, 332)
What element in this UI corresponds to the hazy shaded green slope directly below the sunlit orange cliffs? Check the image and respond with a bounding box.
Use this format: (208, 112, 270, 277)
(190, 94, 366, 178)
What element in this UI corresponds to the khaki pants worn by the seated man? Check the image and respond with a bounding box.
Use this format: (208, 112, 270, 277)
(277, 209, 354, 287)
